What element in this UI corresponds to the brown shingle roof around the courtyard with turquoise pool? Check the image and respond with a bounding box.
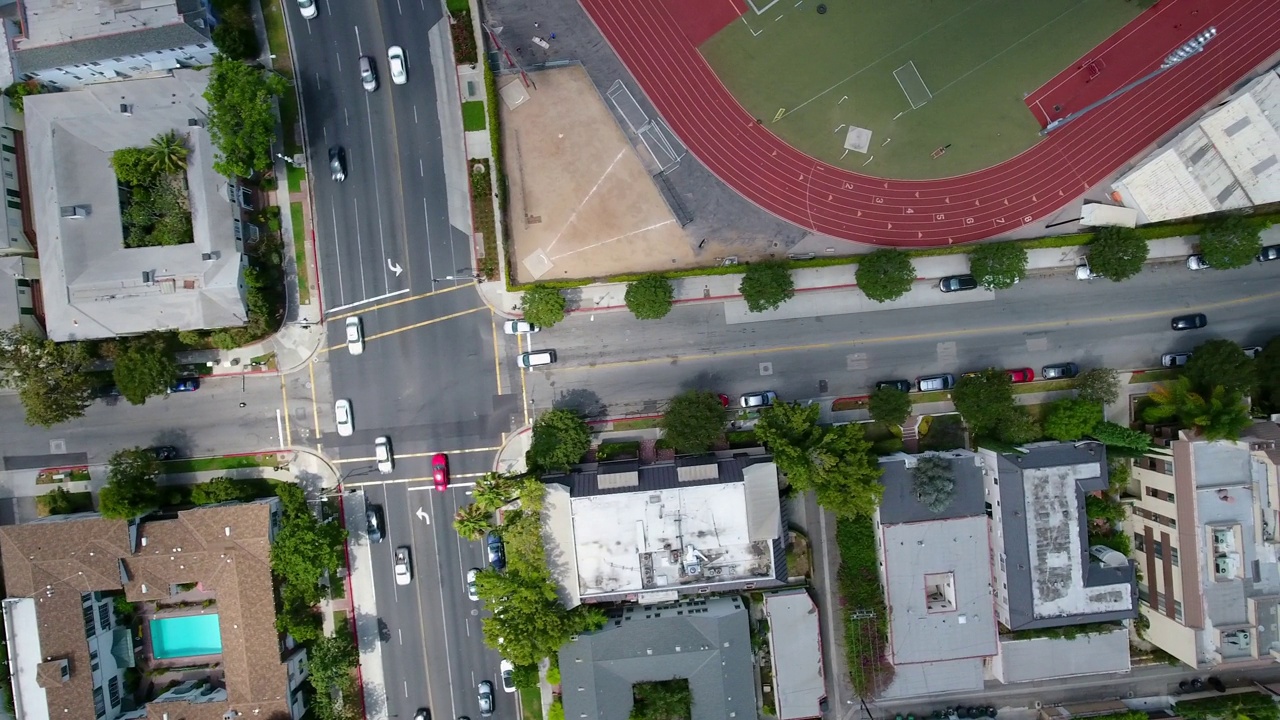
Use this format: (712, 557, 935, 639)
(0, 502, 289, 720)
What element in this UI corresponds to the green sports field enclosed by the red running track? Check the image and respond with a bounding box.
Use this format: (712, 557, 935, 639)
(701, 0, 1140, 179)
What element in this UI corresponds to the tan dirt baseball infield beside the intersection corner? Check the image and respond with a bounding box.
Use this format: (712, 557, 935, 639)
(498, 65, 707, 283)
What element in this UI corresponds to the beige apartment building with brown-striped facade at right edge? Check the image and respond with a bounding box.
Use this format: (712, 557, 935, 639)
(1126, 421, 1280, 669)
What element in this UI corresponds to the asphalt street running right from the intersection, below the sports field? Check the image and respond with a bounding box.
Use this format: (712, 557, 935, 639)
(526, 263, 1280, 416)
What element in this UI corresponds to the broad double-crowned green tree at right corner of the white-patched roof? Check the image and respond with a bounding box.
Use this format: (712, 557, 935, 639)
(755, 402, 884, 518)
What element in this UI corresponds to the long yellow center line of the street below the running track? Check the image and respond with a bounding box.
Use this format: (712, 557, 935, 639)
(573, 292, 1280, 371)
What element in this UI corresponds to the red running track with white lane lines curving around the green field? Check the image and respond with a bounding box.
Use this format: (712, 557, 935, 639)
(580, 0, 1280, 247)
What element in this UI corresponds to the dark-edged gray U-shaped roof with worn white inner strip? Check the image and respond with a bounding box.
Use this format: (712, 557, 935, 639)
(980, 442, 1138, 630)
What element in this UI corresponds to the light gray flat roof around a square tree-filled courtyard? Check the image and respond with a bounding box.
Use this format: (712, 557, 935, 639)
(26, 69, 246, 341)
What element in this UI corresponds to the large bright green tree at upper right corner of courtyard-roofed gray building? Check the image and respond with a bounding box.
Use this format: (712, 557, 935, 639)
(205, 54, 288, 178)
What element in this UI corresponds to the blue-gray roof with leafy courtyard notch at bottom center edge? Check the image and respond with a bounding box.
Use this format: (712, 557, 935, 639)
(559, 597, 755, 720)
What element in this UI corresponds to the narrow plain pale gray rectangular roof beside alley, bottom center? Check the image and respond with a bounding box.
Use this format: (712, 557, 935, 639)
(764, 588, 827, 720)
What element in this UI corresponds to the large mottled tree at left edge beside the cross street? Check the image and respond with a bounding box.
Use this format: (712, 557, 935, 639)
(0, 325, 93, 428)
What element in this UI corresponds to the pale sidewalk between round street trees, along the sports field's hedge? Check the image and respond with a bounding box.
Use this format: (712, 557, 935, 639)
(477, 237, 1196, 322)
